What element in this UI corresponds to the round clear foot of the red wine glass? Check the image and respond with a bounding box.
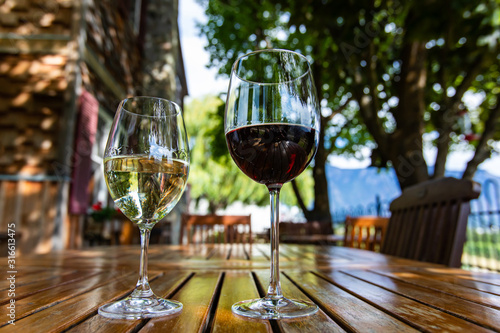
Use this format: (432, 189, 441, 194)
(231, 297, 318, 319)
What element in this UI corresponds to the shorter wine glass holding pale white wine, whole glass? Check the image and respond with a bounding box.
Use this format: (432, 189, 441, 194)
(99, 97, 189, 319)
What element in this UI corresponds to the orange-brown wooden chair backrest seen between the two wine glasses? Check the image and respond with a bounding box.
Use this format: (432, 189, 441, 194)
(180, 214, 252, 244)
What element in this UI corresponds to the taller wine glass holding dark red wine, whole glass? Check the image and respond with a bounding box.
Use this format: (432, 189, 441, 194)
(225, 49, 320, 319)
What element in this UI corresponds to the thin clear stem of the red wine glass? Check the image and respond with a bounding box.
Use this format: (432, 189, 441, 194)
(266, 186, 283, 300)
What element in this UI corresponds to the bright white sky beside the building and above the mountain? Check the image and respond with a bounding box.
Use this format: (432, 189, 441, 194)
(179, 0, 500, 177)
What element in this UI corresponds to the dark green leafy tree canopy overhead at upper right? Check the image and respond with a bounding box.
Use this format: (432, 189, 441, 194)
(200, 0, 500, 164)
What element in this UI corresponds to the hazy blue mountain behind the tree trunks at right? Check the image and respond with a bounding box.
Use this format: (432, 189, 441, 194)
(326, 165, 500, 220)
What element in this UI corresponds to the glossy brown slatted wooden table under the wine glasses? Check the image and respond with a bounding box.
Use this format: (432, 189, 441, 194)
(0, 244, 500, 333)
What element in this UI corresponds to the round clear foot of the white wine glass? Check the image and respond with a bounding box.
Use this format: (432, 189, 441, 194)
(99, 294, 182, 319)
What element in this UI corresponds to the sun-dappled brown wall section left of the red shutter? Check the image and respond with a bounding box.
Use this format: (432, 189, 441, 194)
(0, 0, 73, 175)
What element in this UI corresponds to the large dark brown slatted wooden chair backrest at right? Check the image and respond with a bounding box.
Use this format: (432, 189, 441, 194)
(381, 177, 481, 267)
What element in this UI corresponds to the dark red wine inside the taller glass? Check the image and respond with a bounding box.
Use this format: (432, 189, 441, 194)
(226, 124, 318, 186)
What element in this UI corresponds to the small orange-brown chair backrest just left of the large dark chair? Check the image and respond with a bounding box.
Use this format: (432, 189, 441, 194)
(344, 216, 389, 252)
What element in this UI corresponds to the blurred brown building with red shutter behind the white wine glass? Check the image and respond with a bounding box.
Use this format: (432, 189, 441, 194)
(0, 0, 187, 253)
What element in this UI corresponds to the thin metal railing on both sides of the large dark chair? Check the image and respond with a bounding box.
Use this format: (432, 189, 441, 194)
(332, 178, 500, 272)
